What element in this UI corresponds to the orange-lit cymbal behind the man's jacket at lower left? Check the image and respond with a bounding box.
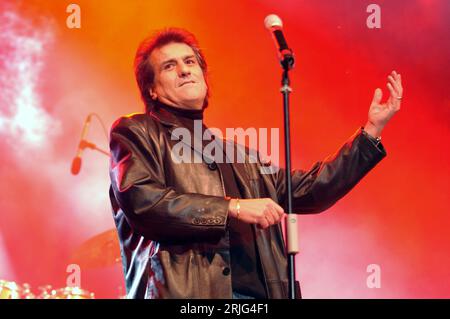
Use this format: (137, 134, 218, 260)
(70, 229, 121, 268)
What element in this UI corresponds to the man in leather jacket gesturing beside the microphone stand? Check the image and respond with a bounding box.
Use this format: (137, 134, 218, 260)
(110, 29, 402, 298)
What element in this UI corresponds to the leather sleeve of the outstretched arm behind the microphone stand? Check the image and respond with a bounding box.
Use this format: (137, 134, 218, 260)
(275, 128, 386, 214)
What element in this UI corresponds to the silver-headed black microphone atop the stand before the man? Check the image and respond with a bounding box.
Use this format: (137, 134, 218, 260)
(264, 14, 294, 70)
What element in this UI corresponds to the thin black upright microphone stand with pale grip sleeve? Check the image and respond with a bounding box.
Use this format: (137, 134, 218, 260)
(280, 54, 301, 299)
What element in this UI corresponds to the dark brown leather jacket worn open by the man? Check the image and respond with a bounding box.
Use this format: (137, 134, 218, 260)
(110, 109, 386, 298)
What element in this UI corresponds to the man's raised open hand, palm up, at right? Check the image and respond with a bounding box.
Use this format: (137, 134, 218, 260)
(364, 71, 403, 137)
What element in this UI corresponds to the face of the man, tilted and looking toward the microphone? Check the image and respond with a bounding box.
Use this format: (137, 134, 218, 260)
(150, 43, 207, 109)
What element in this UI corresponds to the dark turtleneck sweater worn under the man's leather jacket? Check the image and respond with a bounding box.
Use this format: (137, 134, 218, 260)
(156, 102, 266, 299)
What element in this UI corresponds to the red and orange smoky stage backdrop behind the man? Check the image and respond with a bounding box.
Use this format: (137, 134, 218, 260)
(0, 0, 450, 298)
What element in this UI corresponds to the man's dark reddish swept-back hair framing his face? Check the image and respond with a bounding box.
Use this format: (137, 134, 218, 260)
(134, 28, 209, 112)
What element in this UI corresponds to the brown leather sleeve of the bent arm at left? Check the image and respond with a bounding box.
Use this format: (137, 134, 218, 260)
(110, 115, 229, 242)
